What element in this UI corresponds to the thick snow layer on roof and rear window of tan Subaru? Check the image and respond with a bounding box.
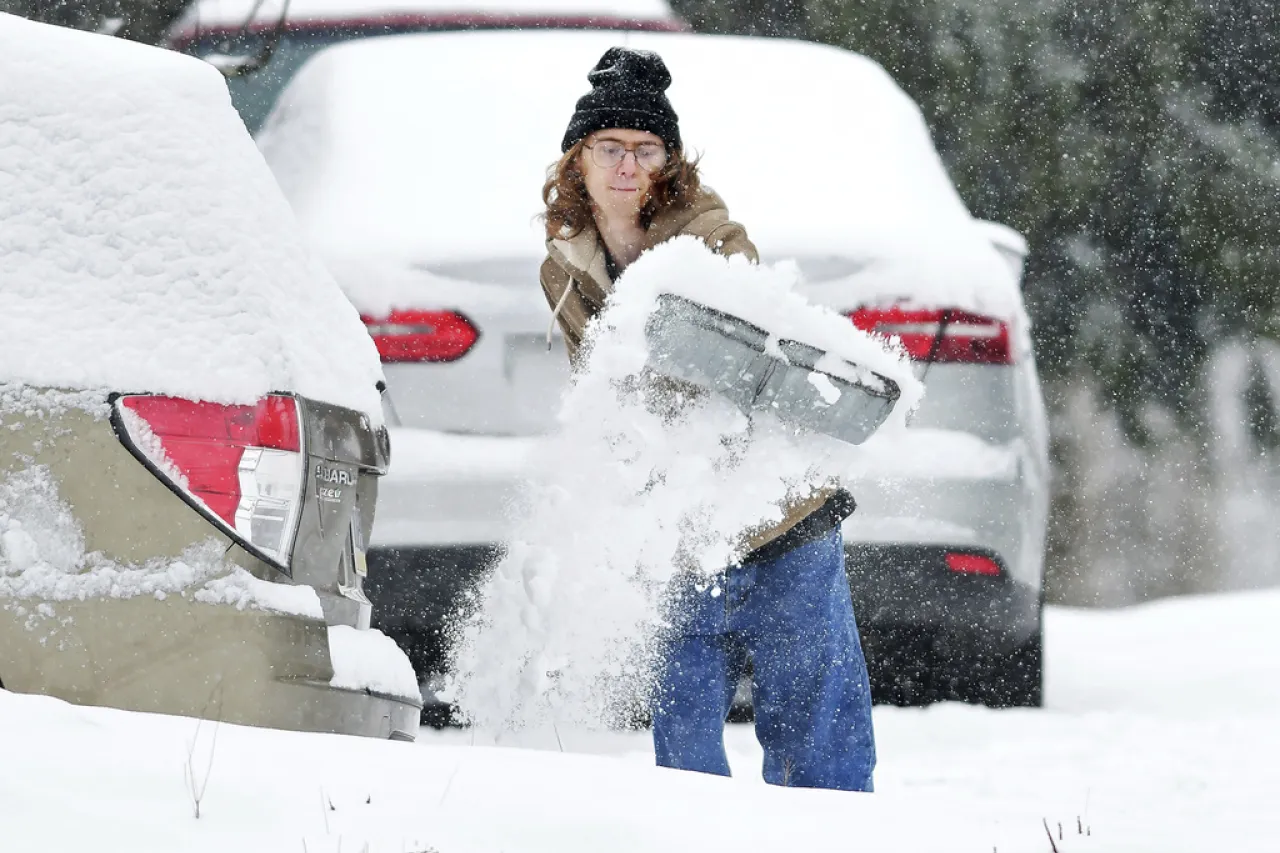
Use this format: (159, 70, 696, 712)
(0, 14, 381, 412)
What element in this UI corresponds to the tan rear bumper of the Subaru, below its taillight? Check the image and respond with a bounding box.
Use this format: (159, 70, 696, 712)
(0, 596, 421, 740)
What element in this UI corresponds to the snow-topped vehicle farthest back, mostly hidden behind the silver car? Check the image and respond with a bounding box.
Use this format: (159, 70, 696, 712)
(169, 0, 689, 133)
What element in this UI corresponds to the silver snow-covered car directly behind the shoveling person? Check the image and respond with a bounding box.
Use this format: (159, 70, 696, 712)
(259, 32, 1047, 704)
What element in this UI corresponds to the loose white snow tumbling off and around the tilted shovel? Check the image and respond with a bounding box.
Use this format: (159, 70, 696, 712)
(451, 238, 922, 727)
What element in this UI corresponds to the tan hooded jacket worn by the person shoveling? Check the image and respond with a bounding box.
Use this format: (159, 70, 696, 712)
(540, 190, 835, 553)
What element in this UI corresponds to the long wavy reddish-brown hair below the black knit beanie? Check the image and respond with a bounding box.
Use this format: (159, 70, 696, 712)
(541, 140, 703, 240)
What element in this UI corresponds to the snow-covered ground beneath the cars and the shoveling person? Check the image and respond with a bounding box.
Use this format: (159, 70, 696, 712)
(0, 592, 1280, 853)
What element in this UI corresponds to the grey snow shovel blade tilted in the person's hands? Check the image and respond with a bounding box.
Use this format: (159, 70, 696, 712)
(645, 293, 901, 444)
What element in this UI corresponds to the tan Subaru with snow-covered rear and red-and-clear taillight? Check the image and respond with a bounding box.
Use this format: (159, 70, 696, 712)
(0, 14, 421, 739)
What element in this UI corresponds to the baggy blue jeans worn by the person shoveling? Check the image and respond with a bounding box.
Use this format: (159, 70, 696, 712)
(653, 528, 876, 792)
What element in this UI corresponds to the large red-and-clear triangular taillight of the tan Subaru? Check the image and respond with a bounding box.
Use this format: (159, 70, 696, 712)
(115, 394, 305, 570)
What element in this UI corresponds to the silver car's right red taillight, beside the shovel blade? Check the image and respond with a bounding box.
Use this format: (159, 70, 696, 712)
(850, 307, 1014, 364)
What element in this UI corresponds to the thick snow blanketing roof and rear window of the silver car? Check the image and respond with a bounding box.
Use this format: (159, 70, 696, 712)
(259, 32, 1020, 314)
